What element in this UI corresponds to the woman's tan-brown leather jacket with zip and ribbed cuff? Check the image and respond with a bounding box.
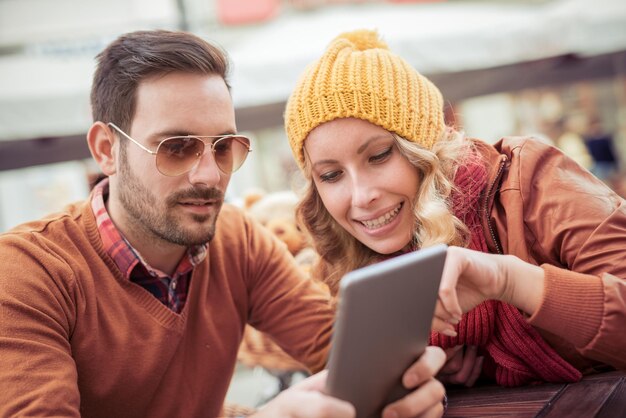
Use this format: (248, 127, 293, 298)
(476, 137, 626, 373)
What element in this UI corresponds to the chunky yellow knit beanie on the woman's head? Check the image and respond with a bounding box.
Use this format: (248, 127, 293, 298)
(284, 30, 444, 167)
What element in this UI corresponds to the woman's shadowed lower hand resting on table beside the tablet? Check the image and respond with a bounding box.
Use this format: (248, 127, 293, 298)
(437, 345, 484, 387)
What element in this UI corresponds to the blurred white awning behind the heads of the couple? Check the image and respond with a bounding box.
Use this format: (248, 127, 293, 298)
(0, 0, 626, 140)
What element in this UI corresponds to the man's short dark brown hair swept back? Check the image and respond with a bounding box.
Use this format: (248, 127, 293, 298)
(91, 30, 230, 129)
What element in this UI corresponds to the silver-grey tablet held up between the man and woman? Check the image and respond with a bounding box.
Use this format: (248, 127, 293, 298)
(326, 245, 447, 418)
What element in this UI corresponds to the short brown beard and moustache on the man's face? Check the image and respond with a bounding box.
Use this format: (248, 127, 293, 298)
(118, 145, 224, 247)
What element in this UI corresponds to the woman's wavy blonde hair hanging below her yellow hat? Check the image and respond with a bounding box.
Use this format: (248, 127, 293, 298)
(296, 128, 473, 294)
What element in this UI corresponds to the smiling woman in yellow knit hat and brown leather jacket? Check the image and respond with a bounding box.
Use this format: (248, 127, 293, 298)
(285, 31, 626, 386)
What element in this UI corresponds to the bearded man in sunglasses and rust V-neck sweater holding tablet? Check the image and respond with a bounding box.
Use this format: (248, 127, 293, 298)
(0, 31, 443, 417)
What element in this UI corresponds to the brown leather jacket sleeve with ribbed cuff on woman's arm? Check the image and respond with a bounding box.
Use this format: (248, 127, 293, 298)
(508, 141, 626, 369)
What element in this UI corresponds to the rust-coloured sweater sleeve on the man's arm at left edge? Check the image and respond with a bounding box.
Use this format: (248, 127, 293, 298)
(0, 233, 80, 417)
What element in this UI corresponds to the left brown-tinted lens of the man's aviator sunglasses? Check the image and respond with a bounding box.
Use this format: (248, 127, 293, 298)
(156, 137, 204, 176)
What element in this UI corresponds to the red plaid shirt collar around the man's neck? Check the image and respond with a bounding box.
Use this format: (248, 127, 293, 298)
(91, 178, 207, 280)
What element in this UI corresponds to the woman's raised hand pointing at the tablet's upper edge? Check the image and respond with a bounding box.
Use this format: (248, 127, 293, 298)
(433, 247, 544, 335)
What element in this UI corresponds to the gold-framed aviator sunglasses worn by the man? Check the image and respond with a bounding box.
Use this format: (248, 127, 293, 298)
(108, 122, 252, 177)
